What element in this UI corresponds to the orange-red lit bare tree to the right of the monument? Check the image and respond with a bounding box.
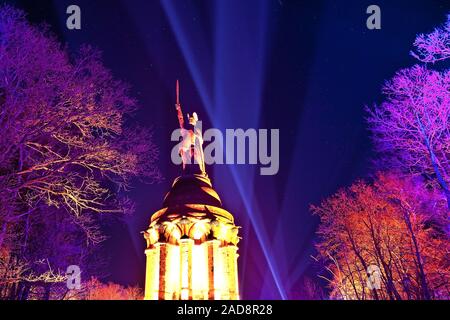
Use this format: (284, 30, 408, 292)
(312, 174, 450, 300)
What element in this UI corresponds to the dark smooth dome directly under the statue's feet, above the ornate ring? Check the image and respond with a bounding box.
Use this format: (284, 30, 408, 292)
(163, 174, 222, 208)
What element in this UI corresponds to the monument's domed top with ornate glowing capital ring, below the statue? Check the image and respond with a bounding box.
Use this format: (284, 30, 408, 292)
(148, 174, 239, 247)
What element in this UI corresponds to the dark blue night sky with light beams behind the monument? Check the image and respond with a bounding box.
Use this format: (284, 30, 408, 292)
(6, 0, 450, 299)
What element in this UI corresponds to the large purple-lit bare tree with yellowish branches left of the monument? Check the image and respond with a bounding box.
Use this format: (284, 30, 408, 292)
(0, 6, 159, 298)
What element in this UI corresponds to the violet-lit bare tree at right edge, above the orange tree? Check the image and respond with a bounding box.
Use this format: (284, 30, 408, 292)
(368, 16, 450, 208)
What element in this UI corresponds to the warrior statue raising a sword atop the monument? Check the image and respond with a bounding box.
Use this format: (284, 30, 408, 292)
(175, 80, 206, 176)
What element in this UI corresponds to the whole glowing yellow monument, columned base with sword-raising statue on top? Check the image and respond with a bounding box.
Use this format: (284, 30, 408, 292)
(144, 81, 243, 300)
